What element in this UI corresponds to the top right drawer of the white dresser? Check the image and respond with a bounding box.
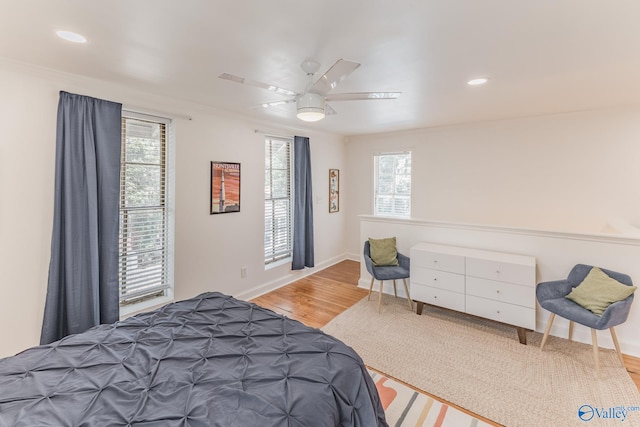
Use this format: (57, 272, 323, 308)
(466, 258, 536, 287)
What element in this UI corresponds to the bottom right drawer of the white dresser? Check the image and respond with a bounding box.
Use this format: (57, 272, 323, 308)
(465, 295, 536, 330)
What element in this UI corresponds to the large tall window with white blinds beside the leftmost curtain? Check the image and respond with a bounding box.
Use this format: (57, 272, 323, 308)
(119, 112, 173, 308)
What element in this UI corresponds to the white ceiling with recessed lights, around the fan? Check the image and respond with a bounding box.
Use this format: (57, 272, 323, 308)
(0, 0, 640, 135)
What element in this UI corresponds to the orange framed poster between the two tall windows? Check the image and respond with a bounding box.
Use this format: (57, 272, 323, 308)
(209, 162, 240, 215)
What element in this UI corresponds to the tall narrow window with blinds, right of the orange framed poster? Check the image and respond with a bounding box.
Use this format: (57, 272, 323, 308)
(264, 137, 293, 265)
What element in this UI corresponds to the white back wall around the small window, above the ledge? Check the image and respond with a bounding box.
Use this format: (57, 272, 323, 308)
(347, 106, 640, 260)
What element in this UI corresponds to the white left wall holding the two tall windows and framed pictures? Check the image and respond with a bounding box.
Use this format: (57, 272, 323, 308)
(0, 60, 346, 357)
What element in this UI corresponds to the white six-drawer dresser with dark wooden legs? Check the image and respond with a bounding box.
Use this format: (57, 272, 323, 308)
(410, 243, 536, 344)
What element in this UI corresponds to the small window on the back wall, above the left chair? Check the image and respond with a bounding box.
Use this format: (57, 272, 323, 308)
(373, 152, 411, 218)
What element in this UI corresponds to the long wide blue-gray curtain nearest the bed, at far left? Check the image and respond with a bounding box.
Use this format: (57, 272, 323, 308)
(40, 92, 122, 344)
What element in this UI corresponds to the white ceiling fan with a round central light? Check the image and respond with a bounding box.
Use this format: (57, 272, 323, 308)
(218, 59, 401, 122)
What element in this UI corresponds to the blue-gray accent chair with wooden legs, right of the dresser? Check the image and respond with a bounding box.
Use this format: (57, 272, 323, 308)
(536, 264, 633, 375)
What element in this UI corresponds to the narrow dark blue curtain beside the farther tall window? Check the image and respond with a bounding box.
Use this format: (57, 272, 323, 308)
(291, 136, 314, 270)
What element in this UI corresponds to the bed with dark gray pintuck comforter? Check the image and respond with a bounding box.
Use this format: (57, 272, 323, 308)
(0, 292, 387, 427)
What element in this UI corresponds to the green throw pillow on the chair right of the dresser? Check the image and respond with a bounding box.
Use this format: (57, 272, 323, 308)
(567, 267, 637, 316)
